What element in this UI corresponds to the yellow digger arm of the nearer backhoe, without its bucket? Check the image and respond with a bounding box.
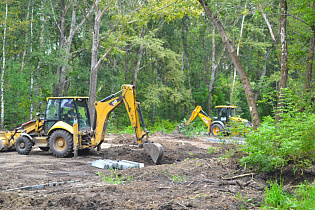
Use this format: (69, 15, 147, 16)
(92, 85, 148, 145)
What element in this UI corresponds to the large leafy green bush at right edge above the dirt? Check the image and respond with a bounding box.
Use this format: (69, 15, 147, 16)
(240, 90, 315, 171)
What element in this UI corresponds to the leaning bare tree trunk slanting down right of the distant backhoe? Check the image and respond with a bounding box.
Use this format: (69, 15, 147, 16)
(199, 0, 260, 129)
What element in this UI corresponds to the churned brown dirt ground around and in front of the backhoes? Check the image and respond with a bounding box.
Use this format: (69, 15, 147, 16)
(0, 133, 315, 209)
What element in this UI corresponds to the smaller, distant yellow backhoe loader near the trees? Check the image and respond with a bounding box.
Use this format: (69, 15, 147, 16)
(186, 106, 252, 136)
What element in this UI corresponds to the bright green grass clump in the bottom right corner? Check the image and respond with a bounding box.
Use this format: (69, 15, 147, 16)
(263, 181, 315, 209)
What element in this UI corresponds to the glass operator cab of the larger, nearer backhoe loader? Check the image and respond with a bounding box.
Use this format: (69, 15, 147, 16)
(44, 97, 91, 133)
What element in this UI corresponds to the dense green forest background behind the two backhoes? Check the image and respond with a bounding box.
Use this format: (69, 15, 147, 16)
(0, 0, 315, 136)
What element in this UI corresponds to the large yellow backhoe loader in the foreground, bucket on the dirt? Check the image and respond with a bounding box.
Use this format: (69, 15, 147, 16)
(0, 85, 164, 164)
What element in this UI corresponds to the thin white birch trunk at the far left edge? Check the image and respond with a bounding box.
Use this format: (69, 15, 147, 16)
(1, 3, 8, 129)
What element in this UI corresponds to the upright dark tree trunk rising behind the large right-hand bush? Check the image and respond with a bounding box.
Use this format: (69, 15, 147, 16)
(276, 0, 289, 122)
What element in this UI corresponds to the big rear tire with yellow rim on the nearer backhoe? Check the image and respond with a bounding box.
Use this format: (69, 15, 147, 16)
(49, 130, 73, 157)
